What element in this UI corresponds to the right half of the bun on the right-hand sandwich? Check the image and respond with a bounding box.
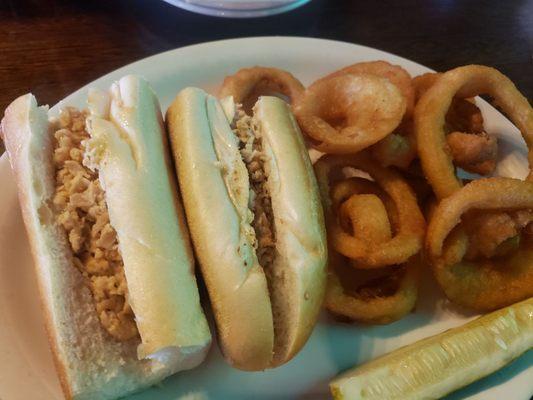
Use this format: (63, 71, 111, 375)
(254, 96, 327, 365)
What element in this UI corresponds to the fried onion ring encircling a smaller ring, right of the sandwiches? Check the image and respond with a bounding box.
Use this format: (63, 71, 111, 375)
(315, 154, 425, 268)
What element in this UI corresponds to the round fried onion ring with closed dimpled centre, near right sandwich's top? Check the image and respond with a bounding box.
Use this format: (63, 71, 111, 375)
(293, 75, 406, 154)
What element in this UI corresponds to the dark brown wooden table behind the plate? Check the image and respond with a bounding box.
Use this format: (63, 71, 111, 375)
(0, 0, 533, 153)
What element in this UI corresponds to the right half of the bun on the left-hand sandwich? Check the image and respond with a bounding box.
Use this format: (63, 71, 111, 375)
(87, 75, 210, 363)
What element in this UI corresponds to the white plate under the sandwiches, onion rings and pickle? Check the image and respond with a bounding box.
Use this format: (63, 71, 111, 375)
(0, 37, 533, 400)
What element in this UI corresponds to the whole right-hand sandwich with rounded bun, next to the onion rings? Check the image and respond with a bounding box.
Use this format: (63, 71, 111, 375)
(166, 88, 327, 370)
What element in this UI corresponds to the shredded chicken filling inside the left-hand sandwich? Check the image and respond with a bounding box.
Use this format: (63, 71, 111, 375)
(54, 108, 138, 341)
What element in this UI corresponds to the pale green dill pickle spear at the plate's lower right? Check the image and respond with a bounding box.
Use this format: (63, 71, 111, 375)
(330, 298, 533, 400)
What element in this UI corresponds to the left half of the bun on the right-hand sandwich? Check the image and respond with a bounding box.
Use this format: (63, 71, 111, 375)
(167, 88, 274, 370)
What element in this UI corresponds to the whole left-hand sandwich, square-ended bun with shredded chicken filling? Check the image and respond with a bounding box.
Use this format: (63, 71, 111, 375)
(2, 76, 211, 399)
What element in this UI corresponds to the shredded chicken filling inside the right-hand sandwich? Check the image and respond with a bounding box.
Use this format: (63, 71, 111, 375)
(234, 111, 276, 268)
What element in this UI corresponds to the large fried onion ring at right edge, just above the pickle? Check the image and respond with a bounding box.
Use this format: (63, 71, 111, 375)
(426, 178, 533, 311)
